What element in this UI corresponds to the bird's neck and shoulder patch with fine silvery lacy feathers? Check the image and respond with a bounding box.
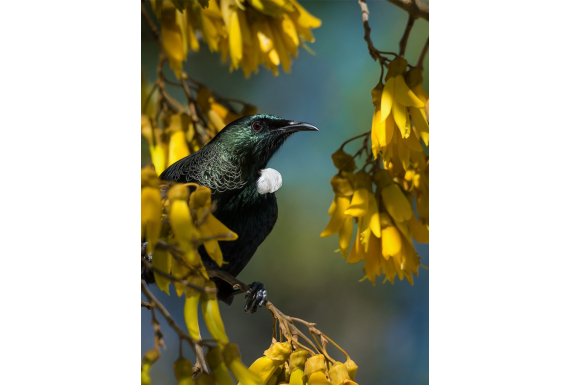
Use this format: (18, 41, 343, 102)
(160, 146, 245, 192)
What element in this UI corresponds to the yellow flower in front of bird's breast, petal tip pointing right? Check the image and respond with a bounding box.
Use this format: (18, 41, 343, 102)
(190, 186, 238, 266)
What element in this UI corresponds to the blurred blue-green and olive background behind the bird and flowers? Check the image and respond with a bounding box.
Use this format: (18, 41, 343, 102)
(141, 0, 429, 385)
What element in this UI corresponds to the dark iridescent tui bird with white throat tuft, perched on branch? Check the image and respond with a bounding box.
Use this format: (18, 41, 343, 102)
(155, 115, 318, 313)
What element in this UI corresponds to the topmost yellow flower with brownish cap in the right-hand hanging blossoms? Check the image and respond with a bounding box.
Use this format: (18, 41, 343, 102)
(380, 57, 425, 138)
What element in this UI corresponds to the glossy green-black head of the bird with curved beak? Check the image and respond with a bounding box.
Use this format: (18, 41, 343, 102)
(213, 114, 319, 178)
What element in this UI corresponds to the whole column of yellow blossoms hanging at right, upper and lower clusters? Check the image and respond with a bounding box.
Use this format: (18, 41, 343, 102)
(321, 57, 429, 284)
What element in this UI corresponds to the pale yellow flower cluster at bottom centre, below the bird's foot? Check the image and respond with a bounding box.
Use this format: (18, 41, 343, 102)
(240, 342, 358, 385)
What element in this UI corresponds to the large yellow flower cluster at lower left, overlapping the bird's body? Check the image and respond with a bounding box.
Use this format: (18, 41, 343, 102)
(141, 166, 270, 385)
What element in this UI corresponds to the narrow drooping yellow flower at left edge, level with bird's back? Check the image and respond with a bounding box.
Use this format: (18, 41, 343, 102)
(141, 166, 162, 252)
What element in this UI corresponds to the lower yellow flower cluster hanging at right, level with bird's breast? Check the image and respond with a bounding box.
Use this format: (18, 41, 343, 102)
(321, 133, 429, 284)
